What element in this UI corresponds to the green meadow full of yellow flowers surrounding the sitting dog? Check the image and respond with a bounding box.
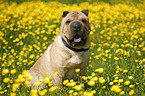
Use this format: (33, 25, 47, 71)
(0, 1, 145, 96)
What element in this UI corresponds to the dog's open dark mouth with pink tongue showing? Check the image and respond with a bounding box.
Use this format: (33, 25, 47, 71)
(67, 35, 87, 47)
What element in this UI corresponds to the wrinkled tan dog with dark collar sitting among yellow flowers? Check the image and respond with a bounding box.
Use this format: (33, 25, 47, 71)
(29, 10, 91, 88)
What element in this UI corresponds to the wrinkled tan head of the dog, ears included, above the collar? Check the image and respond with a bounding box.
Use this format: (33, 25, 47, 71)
(60, 10, 90, 47)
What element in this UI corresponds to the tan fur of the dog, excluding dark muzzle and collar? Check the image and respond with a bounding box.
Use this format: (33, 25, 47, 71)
(29, 11, 90, 87)
